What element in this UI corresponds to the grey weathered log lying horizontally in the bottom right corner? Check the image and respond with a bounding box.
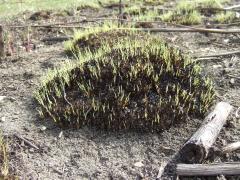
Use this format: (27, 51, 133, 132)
(176, 162, 240, 176)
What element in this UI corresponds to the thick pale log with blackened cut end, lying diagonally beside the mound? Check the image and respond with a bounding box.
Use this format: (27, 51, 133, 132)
(180, 102, 233, 163)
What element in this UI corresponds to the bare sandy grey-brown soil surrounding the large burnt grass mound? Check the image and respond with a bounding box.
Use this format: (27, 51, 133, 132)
(0, 3, 240, 180)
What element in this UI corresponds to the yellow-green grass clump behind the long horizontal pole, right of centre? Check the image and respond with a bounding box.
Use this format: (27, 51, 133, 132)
(161, 1, 202, 25)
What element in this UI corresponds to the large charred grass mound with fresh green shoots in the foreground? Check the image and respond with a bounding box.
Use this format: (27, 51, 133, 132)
(35, 33, 214, 131)
